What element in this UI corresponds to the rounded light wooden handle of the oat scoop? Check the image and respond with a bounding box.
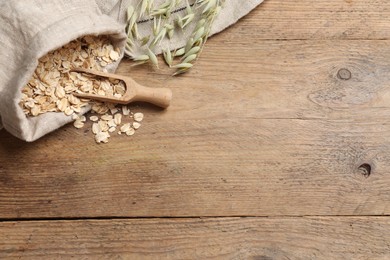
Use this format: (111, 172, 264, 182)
(132, 84, 172, 108)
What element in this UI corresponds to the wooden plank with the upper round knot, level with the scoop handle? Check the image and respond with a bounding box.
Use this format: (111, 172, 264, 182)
(124, 39, 390, 120)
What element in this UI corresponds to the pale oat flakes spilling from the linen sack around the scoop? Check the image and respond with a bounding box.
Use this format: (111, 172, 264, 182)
(19, 36, 144, 143)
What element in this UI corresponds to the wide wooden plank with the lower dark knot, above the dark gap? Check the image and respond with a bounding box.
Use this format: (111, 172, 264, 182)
(0, 119, 390, 218)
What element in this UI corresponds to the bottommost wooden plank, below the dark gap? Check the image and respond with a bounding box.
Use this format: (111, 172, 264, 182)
(0, 217, 390, 260)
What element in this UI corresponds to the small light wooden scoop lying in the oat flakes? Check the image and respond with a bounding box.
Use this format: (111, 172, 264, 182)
(71, 68, 172, 108)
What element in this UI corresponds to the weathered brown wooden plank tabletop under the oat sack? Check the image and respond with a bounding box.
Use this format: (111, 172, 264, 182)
(0, 0, 390, 260)
